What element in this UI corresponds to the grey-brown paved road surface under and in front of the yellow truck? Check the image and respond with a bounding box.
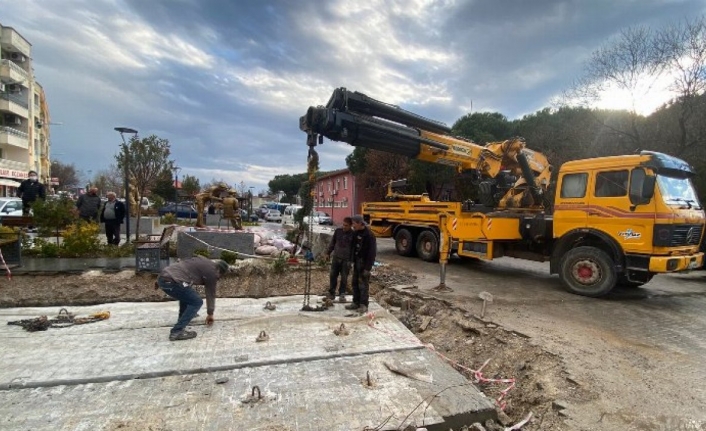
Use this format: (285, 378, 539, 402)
(378, 239, 706, 430)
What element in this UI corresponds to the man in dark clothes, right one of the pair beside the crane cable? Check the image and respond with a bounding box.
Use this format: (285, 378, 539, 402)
(346, 215, 377, 313)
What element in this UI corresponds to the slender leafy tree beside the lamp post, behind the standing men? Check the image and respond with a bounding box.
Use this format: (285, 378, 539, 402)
(115, 135, 173, 240)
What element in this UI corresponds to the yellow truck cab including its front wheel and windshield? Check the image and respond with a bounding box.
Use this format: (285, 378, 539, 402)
(551, 151, 705, 296)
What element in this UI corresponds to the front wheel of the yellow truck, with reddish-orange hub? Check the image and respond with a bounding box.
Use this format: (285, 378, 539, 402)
(559, 247, 618, 297)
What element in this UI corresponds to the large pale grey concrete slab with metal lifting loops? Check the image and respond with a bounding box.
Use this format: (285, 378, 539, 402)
(0, 296, 495, 430)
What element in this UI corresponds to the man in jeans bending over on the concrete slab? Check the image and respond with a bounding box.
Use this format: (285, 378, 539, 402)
(155, 256, 229, 341)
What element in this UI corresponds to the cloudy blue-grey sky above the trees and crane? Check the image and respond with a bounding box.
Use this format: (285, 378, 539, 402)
(0, 0, 706, 191)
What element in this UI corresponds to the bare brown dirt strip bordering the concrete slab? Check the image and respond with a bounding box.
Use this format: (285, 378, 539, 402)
(0, 265, 572, 431)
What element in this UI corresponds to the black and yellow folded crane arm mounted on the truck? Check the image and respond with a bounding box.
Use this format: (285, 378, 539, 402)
(299, 88, 551, 208)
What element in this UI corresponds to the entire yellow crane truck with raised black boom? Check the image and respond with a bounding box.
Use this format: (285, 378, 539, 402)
(300, 88, 706, 297)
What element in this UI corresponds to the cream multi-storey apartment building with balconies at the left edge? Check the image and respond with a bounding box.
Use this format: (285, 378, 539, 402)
(0, 24, 50, 196)
